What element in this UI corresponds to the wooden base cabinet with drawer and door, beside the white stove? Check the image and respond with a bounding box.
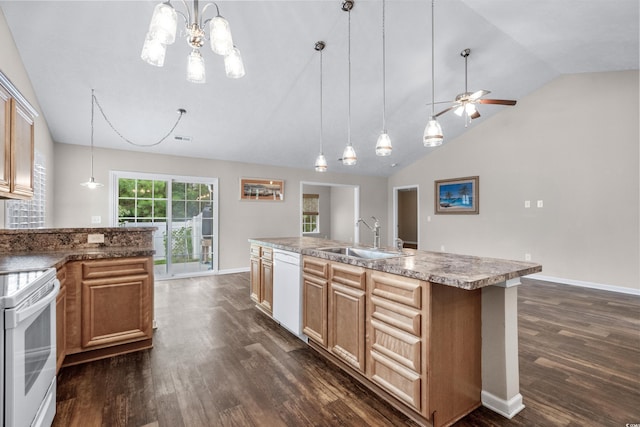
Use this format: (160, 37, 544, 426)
(64, 257, 153, 366)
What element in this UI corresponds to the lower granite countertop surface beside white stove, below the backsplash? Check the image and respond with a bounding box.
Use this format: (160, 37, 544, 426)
(0, 247, 155, 274)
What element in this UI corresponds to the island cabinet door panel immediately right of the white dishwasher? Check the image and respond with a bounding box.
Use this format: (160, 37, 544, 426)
(302, 274, 329, 347)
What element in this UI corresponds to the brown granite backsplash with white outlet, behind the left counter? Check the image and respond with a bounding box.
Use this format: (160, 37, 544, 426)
(0, 227, 156, 253)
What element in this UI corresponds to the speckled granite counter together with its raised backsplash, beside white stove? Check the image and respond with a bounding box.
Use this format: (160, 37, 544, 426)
(0, 227, 155, 273)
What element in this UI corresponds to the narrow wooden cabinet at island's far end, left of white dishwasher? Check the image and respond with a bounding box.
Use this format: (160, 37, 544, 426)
(250, 244, 273, 314)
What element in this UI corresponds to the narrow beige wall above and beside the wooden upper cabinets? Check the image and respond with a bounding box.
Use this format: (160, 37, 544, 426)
(0, 9, 55, 228)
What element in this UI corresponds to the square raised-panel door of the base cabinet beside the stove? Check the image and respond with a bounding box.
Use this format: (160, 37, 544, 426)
(82, 275, 153, 349)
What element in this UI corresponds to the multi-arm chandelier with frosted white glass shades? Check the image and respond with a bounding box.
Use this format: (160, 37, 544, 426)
(140, 0, 245, 83)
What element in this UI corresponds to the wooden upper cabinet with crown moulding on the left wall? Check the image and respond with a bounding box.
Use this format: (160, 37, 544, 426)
(0, 72, 38, 199)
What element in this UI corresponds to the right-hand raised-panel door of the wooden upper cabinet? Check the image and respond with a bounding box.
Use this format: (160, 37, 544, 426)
(11, 100, 34, 197)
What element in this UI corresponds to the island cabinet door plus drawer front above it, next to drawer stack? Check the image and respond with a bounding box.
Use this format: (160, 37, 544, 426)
(327, 263, 366, 372)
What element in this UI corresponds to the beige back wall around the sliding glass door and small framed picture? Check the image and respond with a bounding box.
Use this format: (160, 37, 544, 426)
(55, 144, 387, 270)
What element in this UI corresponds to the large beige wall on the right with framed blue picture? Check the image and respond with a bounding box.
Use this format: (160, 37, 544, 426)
(388, 71, 640, 290)
